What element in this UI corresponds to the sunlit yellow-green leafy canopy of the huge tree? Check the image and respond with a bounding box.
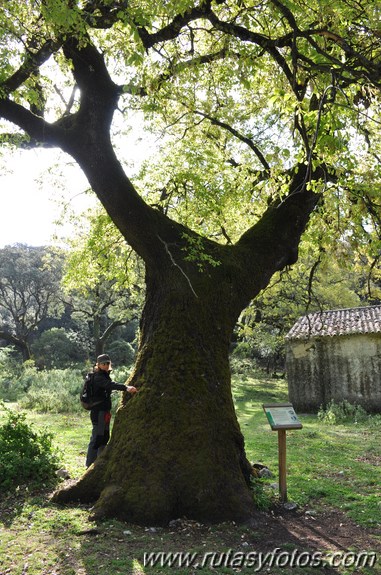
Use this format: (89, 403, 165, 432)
(0, 0, 381, 253)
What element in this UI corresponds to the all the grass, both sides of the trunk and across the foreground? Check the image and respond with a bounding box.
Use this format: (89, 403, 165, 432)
(0, 378, 381, 575)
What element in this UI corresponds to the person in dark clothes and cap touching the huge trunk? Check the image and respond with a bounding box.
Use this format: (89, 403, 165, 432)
(86, 353, 137, 467)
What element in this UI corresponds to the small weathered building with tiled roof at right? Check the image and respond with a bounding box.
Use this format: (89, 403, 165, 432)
(286, 306, 381, 412)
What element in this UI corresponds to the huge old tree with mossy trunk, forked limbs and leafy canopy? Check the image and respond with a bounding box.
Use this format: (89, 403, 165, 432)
(0, 0, 381, 524)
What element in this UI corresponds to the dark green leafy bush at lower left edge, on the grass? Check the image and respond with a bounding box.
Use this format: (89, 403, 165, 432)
(0, 404, 59, 491)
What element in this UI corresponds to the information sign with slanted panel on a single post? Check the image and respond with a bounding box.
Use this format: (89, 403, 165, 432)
(262, 403, 303, 503)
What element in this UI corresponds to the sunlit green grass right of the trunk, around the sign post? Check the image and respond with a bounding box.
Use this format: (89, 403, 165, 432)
(233, 378, 381, 526)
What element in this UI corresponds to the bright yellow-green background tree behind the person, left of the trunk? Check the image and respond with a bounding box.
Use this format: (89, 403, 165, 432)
(62, 210, 143, 361)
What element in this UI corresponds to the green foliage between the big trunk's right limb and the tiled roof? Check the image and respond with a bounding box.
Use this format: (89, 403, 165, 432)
(233, 234, 364, 374)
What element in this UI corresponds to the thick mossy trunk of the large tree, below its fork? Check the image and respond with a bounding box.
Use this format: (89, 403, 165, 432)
(55, 260, 254, 524)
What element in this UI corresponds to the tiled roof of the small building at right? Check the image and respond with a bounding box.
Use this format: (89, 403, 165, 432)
(286, 305, 381, 339)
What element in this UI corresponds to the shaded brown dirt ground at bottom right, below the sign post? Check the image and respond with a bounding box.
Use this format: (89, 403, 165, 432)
(154, 507, 381, 575)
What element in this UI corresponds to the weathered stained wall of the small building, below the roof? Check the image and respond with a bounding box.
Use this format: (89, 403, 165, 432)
(286, 334, 381, 412)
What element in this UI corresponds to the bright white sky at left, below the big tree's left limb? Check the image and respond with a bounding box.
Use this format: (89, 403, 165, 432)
(0, 150, 96, 248)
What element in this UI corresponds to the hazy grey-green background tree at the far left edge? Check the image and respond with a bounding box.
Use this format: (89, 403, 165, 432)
(0, 245, 63, 361)
